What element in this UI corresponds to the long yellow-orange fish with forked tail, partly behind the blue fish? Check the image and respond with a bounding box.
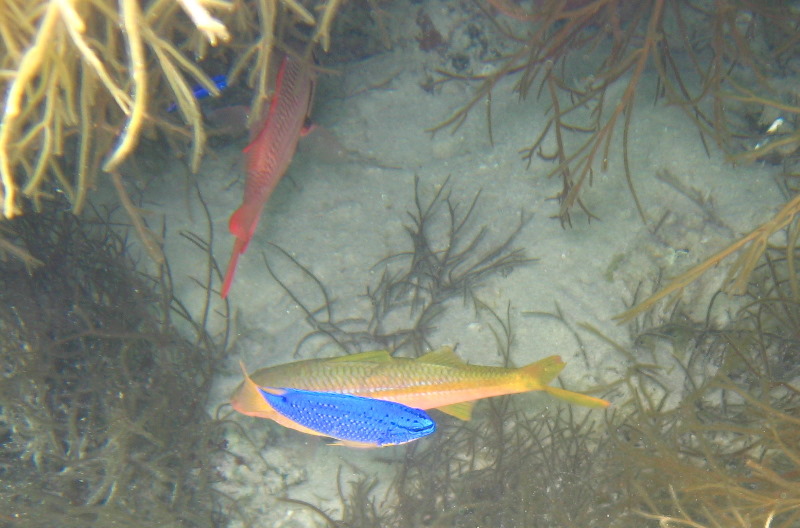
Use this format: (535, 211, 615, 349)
(231, 347, 608, 420)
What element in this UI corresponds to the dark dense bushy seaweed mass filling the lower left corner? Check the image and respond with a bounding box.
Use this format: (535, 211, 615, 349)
(0, 202, 230, 528)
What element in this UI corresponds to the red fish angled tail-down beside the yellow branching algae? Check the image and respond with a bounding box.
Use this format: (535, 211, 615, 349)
(220, 55, 314, 299)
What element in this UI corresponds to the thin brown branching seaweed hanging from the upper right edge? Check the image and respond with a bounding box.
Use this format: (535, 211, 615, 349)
(432, 0, 800, 223)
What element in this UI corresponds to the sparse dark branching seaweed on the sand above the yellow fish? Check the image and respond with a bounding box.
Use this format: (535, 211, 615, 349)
(265, 178, 535, 356)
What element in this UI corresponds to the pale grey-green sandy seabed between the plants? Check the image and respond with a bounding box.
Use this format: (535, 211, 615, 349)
(131, 4, 783, 527)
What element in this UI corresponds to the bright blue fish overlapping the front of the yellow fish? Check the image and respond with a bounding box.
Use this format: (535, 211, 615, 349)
(258, 387, 436, 447)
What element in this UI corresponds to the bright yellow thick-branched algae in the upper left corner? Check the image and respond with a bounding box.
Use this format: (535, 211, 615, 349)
(0, 0, 340, 218)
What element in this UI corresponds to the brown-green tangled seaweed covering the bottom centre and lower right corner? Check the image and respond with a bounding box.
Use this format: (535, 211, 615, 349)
(276, 189, 800, 528)
